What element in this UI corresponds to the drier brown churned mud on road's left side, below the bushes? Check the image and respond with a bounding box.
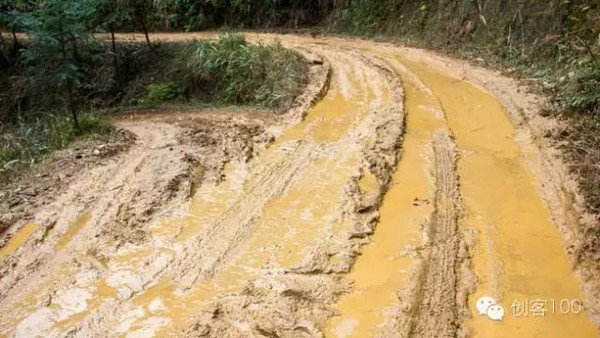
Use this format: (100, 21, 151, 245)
(0, 111, 271, 336)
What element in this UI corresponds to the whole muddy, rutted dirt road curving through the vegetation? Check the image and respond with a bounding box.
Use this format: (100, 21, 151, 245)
(0, 33, 599, 337)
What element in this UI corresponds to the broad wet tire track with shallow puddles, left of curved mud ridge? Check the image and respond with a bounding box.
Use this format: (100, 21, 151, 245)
(62, 48, 402, 336)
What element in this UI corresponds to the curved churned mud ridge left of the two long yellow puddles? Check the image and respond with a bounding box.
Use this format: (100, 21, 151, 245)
(180, 50, 404, 337)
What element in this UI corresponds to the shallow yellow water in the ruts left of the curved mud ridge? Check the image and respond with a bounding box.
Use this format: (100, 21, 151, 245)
(1, 52, 389, 336)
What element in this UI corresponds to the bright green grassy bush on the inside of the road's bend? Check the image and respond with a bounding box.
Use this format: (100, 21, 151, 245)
(170, 34, 308, 108)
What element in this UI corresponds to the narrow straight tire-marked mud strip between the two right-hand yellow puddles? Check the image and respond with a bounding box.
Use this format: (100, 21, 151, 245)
(409, 131, 462, 337)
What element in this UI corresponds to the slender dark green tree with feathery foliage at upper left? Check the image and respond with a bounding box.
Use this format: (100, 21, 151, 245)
(24, 0, 96, 132)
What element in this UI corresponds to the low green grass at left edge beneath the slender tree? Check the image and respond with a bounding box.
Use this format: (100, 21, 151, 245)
(0, 113, 113, 182)
